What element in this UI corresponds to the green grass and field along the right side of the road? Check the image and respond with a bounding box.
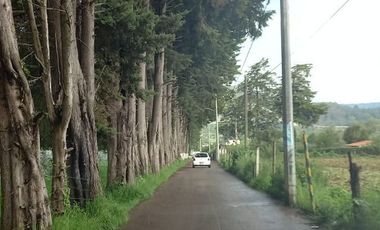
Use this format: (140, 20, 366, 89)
(221, 148, 380, 230)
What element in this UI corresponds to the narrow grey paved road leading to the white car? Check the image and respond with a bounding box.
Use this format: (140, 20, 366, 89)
(122, 164, 311, 230)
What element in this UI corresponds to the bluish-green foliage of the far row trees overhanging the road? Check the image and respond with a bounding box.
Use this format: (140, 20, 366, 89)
(172, 0, 272, 140)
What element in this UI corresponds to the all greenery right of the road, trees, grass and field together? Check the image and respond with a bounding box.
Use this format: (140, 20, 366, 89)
(208, 55, 380, 230)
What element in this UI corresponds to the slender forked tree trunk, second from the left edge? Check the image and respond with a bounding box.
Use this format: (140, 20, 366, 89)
(28, 0, 73, 213)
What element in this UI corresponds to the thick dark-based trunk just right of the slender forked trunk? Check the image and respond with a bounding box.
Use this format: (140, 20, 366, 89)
(68, 0, 101, 207)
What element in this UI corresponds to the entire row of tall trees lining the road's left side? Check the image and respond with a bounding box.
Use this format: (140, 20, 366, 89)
(0, 0, 273, 229)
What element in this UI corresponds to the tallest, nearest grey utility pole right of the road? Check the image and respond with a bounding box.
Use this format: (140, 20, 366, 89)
(281, 0, 296, 206)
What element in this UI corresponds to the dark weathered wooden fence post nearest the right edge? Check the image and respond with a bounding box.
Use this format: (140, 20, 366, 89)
(348, 151, 361, 229)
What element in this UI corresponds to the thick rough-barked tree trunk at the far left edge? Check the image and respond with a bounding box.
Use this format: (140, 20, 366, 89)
(0, 0, 51, 227)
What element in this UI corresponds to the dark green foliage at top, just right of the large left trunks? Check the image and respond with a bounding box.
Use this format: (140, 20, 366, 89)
(95, 0, 159, 93)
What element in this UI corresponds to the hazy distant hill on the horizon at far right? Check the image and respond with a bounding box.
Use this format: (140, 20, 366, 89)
(318, 103, 380, 125)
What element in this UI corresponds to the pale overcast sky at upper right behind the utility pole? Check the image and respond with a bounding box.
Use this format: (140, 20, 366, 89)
(238, 0, 380, 103)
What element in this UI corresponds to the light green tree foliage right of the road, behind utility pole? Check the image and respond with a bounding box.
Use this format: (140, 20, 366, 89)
(221, 62, 327, 145)
